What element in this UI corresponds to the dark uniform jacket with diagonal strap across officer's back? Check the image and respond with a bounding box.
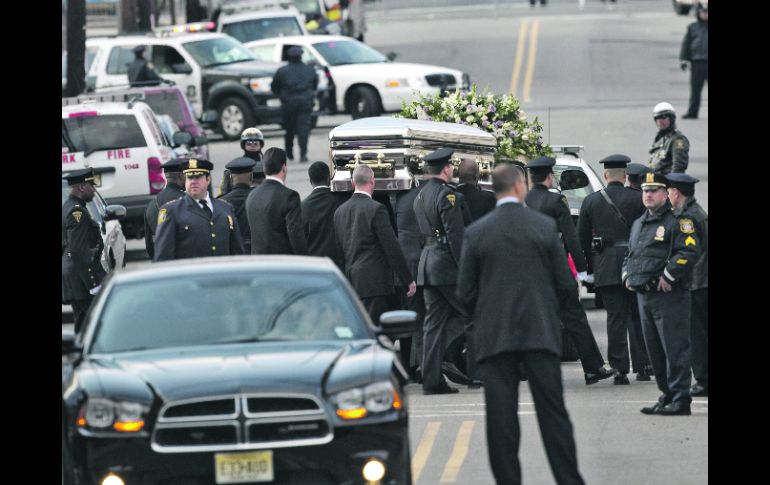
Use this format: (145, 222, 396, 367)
(578, 182, 644, 288)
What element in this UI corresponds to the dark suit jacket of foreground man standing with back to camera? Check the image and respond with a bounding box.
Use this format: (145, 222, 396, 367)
(457, 203, 577, 361)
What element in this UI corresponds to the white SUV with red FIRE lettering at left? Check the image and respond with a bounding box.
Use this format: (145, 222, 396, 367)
(61, 95, 174, 237)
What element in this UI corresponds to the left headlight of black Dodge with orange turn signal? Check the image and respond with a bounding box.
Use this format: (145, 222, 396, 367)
(77, 398, 148, 433)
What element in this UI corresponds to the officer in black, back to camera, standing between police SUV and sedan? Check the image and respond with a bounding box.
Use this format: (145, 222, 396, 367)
(270, 46, 318, 162)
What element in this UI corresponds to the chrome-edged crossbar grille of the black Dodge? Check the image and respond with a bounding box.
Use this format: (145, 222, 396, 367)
(152, 394, 334, 453)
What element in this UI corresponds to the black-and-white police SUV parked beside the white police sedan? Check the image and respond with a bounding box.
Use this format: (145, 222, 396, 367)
(86, 30, 327, 140)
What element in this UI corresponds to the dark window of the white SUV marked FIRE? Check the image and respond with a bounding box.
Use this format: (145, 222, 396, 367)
(61, 115, 147, 154)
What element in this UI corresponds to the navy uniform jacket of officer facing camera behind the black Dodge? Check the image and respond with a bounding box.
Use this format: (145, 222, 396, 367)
(154, 194, 243, 261)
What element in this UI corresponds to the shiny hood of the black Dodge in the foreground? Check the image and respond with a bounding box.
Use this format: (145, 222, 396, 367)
(87, 341, 378, 402)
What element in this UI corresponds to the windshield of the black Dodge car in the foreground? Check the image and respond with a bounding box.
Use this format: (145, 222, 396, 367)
(91, 268, 369, 353)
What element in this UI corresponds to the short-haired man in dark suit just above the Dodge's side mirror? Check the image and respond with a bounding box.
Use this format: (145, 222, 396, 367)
(334, 165, 417, 325)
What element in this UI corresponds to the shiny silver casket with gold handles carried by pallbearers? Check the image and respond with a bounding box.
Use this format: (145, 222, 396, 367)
(329, 117, 497, 192)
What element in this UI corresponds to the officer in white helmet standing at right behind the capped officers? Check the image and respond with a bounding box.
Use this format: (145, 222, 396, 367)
(650, 102, 690, 175)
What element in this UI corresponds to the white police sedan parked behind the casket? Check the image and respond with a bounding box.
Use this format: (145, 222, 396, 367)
(245, 35, 470, 119)
